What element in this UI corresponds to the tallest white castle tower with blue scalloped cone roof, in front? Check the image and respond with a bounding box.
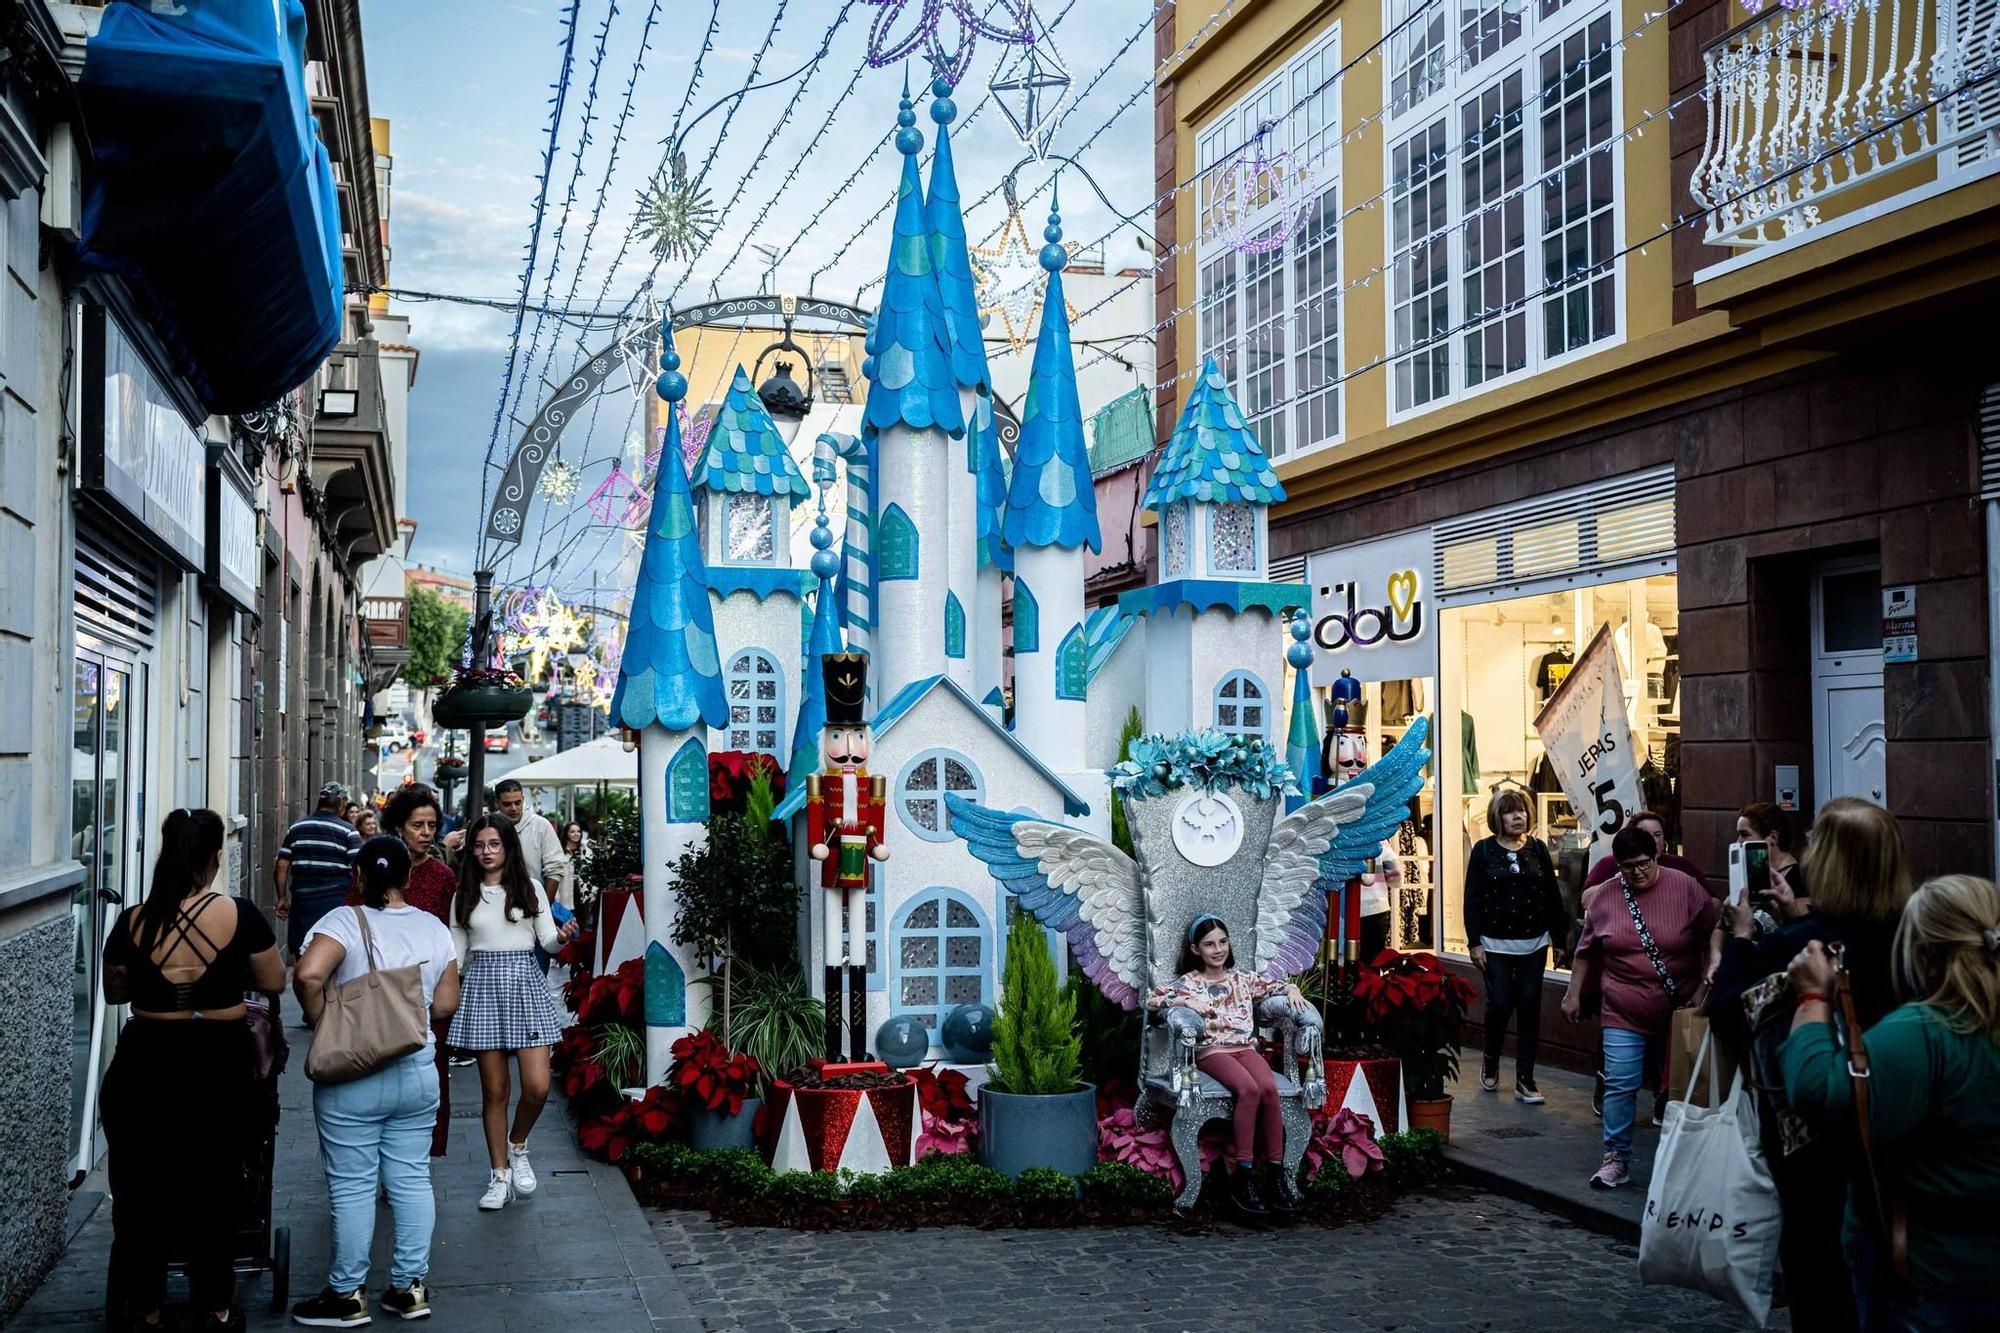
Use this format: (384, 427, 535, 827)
(862, 88, 972, 703)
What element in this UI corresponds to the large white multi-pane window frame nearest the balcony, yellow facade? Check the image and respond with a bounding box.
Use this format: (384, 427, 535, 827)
(1382, 0, 1630, 424)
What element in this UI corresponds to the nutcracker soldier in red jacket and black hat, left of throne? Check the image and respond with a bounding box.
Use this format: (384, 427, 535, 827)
(806, 652, 888, 1061)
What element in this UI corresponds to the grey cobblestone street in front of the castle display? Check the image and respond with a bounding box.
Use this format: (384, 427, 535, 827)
(648, 1189, 1792, 1333)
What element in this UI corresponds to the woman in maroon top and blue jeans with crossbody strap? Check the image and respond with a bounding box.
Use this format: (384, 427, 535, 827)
(1562, 829, 1718, 1189)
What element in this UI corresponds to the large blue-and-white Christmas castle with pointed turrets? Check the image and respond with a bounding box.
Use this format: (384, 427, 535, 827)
(612, 78, 1376, 1057)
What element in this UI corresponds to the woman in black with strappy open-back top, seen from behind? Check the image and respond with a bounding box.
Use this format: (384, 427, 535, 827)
(100, 811, 284, 1329)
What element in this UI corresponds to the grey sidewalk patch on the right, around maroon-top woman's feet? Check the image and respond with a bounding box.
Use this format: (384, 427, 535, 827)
(1446, 1053, 1660, 1243)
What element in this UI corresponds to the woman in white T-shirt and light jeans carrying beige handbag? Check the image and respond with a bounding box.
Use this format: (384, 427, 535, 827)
(292, 837, 458, 1329)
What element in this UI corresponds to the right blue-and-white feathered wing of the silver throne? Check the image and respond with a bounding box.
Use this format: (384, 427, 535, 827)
(1254, 717, 1430, 979)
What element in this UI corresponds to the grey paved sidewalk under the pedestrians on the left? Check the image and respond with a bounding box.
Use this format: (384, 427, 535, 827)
(8, 999, 700, 1333)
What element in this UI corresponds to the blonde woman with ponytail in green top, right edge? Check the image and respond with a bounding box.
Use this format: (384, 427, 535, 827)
(1782, 869, 2000, 1333)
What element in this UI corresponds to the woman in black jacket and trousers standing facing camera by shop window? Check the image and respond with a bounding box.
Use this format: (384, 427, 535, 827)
(1464, 787, 1570, 1107)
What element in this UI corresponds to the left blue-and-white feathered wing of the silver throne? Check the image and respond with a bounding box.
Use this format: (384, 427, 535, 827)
(944, 793, 1146, 1009)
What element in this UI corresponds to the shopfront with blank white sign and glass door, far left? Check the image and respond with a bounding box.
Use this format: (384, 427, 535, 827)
(70, 304, 206, 1171)
